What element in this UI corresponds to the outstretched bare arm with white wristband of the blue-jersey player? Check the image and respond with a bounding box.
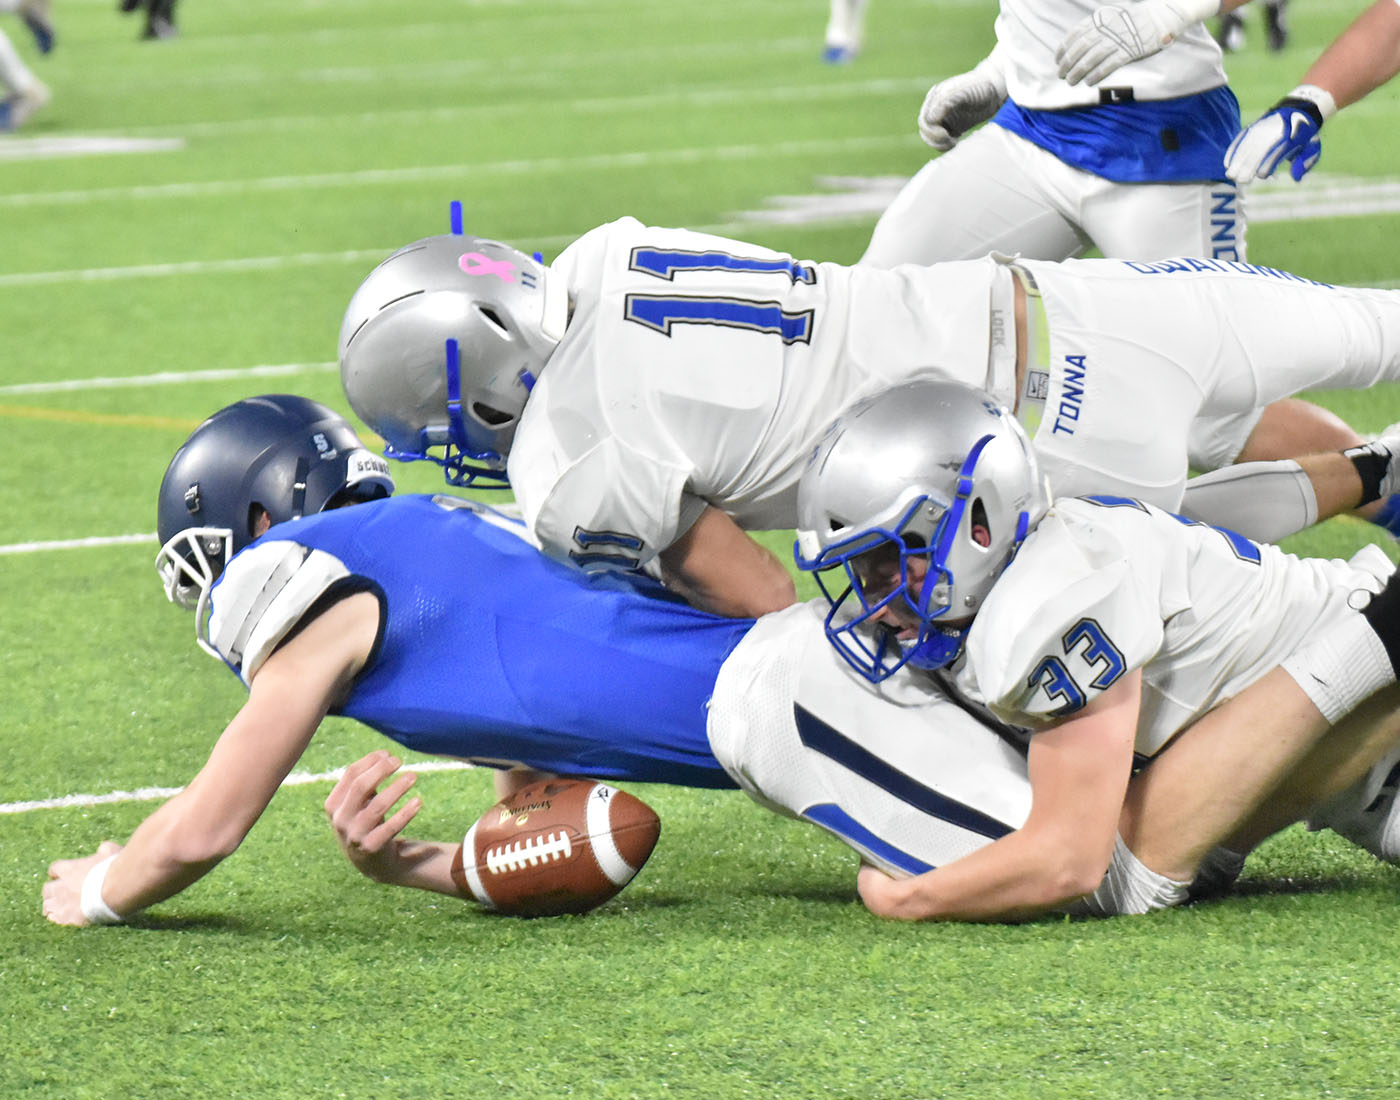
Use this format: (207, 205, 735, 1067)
(43, 593, 379, 925)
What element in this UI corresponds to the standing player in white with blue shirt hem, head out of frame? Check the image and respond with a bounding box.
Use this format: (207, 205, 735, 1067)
(861, 0, 1377, 506)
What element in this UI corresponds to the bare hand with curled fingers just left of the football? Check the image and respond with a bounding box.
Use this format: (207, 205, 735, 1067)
(326, 749, 423, 883)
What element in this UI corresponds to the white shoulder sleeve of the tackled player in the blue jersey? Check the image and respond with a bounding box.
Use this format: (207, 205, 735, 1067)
(209, 539, 350, 683)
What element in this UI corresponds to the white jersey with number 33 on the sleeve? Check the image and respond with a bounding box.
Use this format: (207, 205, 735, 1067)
(958, 497, 1393, 756)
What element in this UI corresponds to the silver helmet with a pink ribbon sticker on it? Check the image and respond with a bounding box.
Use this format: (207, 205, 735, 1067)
(340, 234, 568, 484)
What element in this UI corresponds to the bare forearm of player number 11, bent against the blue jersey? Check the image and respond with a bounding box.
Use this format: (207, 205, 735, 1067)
(661, 505, 797, 619)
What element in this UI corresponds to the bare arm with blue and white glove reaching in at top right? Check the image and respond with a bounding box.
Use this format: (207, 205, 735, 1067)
(1225, 0, 1400, 183)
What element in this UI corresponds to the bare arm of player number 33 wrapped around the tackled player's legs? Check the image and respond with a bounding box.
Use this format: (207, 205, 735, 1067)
(858, 670, 1142, 921)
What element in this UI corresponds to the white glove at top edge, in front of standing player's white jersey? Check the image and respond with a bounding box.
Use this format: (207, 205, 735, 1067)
(1054, 0, 1221, 84)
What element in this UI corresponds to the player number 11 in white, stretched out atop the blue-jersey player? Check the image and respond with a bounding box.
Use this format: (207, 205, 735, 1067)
(339, 218, 1400, 616)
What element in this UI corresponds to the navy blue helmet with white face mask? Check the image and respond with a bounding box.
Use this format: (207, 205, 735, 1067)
(155, 393, 393, 619)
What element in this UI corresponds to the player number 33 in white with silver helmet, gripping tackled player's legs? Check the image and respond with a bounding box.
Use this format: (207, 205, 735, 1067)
(798, 379, 1400, 918)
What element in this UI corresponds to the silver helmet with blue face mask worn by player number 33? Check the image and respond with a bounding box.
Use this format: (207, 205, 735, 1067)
(794, 378, 1050, 683)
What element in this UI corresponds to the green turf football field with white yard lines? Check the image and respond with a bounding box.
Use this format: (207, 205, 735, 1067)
(8, 0, 1400, 1100)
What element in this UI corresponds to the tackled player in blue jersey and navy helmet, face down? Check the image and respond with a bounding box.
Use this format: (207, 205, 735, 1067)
(43, 396, 1390, 924)
